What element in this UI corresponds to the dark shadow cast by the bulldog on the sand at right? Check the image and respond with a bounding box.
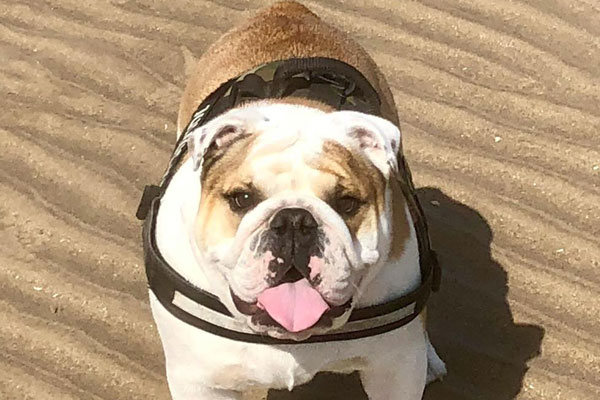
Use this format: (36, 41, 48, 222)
(268, 188, 544, 400)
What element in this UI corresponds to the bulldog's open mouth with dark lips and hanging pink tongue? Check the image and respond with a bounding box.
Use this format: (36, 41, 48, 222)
(231, 278, 351, 333)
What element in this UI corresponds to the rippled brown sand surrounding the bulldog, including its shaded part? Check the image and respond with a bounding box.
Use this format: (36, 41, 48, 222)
(0, 0, 600, 400)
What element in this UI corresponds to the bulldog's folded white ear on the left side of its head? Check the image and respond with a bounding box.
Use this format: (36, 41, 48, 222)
(184, 108, 265, 171)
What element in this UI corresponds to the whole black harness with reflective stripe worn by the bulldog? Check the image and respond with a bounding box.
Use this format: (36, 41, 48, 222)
(136, 57, 441, 344)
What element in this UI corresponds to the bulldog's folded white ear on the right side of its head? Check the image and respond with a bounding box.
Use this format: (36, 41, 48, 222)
(335, 111, 401, 178)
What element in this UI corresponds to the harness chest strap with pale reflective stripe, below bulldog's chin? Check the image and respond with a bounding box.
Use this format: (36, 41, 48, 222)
(143, 198, 433, 344)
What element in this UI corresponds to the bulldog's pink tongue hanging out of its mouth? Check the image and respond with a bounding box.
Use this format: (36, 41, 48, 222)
(258, 279, 329, 332)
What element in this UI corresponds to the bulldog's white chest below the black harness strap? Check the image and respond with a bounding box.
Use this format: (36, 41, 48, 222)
(150, 292, 426, 398)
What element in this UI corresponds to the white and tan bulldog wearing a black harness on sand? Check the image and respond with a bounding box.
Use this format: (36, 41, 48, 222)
(145, 2, 445, 400)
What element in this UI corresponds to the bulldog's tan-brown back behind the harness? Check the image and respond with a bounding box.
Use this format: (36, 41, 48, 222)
(178, 1, 398, 135)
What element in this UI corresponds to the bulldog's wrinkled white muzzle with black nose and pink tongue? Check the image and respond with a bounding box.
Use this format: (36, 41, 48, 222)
(228, 197, 359, 335)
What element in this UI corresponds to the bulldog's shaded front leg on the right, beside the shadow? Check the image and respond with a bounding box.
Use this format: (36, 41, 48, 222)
(360, 340, 427, 400)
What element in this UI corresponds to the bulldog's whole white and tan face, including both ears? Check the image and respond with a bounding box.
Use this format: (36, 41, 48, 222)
(188, 102, 400, 339)
